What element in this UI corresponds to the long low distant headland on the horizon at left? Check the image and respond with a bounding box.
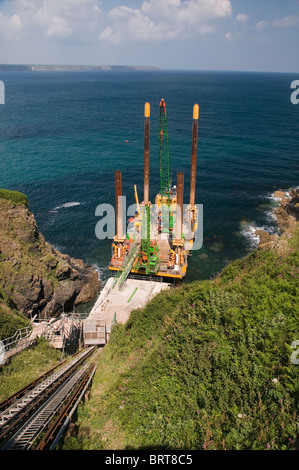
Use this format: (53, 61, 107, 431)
(0, 64, 160, 72)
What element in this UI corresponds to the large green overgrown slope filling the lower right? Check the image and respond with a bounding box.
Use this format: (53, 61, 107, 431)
(64, 224, 299, 449)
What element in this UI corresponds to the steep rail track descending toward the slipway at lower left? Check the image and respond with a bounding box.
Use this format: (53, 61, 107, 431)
(0, 347, 97, 450)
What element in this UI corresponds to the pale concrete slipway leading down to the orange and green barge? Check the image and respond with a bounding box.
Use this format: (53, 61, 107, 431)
(83, 277, 170, 346)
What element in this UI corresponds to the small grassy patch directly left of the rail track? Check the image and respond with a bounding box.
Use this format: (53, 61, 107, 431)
(0, 338, 61, 401)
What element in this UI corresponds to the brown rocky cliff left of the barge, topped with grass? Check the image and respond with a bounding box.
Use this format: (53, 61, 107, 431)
(0, 193, 100, 318)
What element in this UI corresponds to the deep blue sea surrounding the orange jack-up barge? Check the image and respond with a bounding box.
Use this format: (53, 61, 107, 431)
(0, 71, 299, 282)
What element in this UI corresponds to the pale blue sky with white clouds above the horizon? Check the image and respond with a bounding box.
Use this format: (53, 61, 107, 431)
(0, 0, 299, 73)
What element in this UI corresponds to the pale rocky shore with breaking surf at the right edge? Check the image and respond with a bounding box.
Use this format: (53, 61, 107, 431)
(255, 189, 299, 248)
